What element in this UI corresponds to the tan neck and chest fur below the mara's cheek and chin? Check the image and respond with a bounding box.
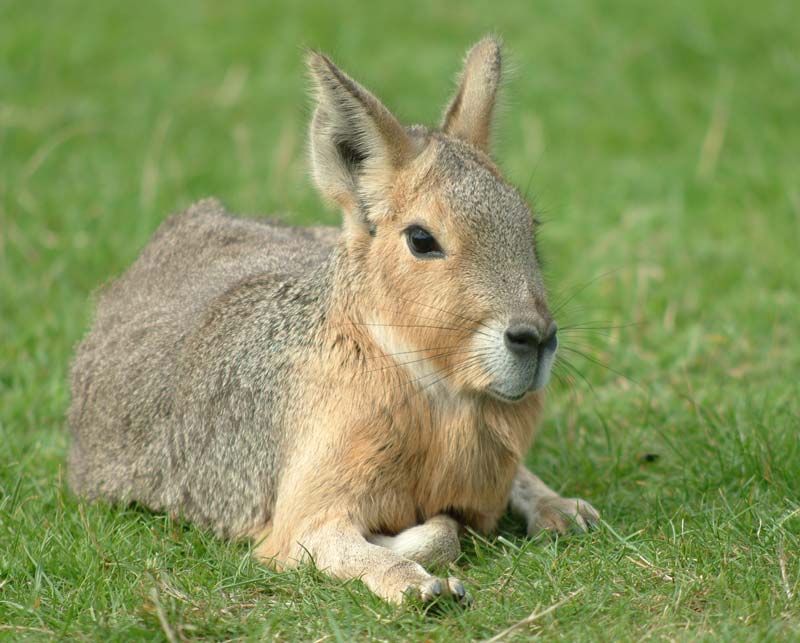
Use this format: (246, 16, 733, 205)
(316, 270, 542, 532)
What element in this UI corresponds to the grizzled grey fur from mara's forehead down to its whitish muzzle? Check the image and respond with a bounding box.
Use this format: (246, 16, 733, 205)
(412, 132, 553, 399)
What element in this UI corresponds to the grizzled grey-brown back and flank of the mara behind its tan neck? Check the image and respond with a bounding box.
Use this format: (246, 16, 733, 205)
(70, 200, 336, 534)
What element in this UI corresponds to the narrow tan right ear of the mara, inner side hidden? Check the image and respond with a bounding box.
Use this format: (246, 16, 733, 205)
(442, 36, 502, 154)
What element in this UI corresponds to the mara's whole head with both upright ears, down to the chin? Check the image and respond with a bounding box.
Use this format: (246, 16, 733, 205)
(308, 38, 557, 401)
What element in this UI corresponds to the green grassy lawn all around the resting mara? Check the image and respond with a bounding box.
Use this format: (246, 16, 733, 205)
(0, 0, 800, 642)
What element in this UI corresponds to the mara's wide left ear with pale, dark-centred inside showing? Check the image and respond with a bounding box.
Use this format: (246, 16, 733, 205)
(307, 51, 413, 223)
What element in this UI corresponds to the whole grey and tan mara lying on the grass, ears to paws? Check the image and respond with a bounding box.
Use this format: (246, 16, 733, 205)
(69, 39, 597, 601)
